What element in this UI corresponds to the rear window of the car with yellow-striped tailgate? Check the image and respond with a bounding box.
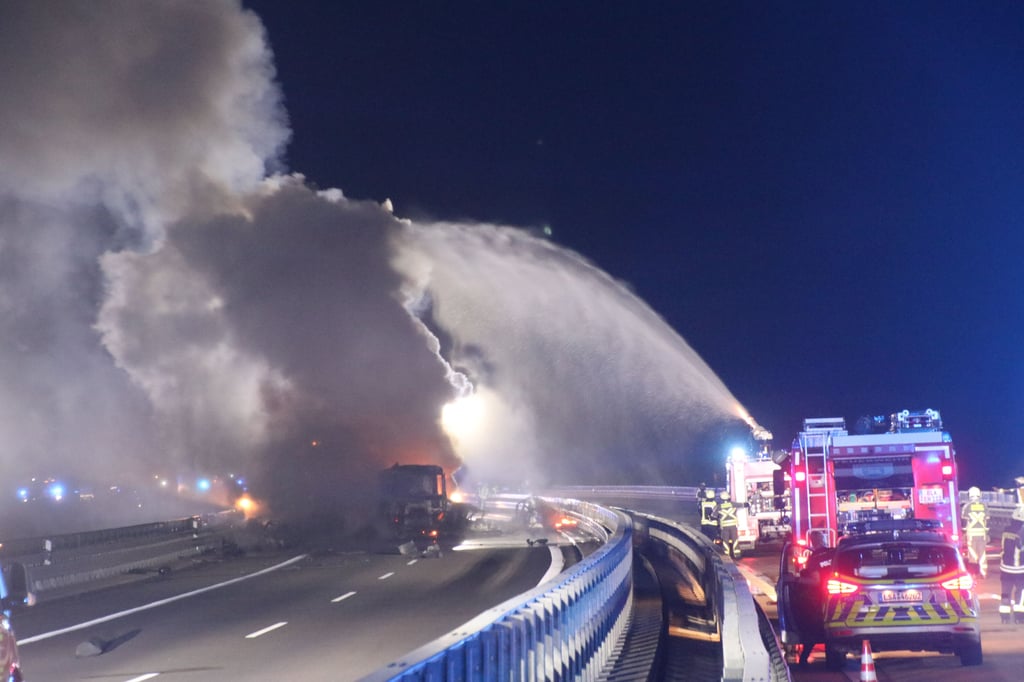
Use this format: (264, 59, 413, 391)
(836, 543, 961, 580)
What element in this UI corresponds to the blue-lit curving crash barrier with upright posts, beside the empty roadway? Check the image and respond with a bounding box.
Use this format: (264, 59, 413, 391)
(364, 499, 633, 682)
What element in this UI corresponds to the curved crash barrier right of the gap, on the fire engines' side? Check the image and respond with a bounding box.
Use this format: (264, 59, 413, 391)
(629, 511, 790, 680)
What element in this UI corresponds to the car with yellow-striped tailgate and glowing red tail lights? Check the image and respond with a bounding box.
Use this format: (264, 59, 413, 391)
(777, 519, 982, 670)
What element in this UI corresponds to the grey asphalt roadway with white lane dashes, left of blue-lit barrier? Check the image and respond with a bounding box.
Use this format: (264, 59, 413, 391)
(15, 547, 552, 682)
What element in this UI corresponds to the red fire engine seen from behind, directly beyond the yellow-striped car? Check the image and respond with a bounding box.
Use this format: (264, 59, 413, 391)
(787, 410, 959, 546)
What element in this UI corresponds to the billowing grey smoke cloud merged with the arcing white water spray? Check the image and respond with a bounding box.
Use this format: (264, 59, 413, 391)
(0, 0, 741, 532)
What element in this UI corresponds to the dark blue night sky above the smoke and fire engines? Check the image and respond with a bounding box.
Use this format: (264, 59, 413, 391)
(246, 1, 1024, 486)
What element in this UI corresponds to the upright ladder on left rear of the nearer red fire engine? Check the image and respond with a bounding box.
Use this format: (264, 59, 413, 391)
(800, 417, 847, 545)
